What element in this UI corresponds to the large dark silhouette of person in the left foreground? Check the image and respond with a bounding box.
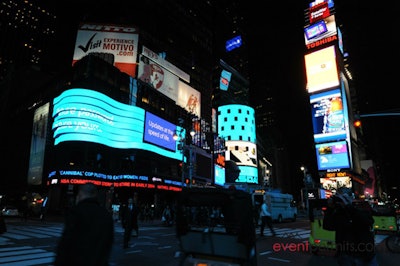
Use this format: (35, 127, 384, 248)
(54, 183, 114, 266)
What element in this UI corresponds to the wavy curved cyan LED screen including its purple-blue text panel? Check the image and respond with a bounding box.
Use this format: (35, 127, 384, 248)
(52, 88, 182, 160)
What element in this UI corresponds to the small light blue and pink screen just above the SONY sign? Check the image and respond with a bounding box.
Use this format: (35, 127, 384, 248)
(315, 141, 350, 171)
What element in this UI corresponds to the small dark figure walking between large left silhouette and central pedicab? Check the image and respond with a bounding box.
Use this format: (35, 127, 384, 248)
(121, 198, 139, 248)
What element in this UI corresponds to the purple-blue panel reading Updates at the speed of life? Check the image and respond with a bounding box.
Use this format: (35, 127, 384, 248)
(144, 112, 176, 151)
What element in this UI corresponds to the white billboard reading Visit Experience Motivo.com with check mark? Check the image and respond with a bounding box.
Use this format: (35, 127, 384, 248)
(72, 23, 139, 77)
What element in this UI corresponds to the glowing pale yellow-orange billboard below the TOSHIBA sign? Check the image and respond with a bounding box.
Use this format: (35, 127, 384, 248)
(304, 45, 339, 93)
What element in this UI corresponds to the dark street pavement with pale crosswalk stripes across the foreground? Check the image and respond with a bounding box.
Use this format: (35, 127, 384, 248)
(0, 215, 400, 266)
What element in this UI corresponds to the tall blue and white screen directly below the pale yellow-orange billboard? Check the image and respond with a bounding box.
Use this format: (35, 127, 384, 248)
(310, 89, 348, 143)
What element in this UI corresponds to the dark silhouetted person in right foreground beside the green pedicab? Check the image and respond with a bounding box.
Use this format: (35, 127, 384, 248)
(322, 187, 378, 266)
